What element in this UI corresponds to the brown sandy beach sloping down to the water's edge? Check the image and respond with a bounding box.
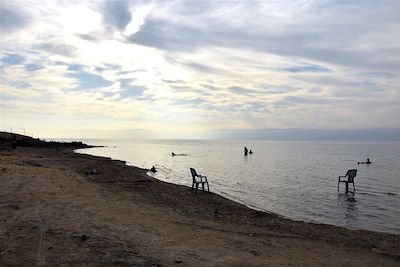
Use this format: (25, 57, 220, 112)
(0, 137, 400, 266)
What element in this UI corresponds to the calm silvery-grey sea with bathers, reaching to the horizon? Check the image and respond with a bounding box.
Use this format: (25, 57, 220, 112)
(74, 140, 400, 234)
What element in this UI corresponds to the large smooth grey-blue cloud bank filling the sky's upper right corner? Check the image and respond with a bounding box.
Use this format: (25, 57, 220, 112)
(129, 1, 400, 70)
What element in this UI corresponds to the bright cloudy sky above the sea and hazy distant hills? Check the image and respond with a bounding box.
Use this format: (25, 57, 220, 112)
(0, 0, 400, 138)
